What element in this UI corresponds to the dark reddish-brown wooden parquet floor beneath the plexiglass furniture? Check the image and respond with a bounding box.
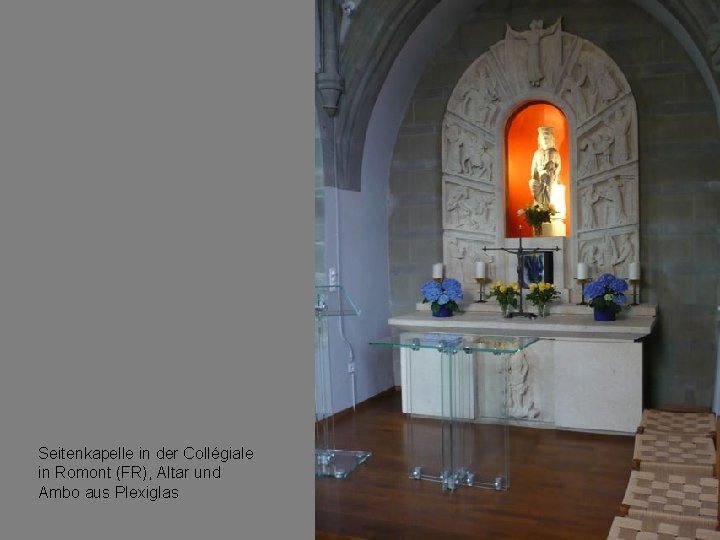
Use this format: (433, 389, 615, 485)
(315, 392, 634, 540)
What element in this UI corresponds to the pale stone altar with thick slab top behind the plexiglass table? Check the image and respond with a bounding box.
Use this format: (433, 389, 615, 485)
(388, 303, 657, 434)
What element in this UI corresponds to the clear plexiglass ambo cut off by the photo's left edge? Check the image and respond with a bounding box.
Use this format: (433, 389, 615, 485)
(315, 285, 371, 478)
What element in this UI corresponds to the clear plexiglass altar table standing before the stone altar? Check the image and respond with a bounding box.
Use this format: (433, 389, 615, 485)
(372, 332, 537, 491)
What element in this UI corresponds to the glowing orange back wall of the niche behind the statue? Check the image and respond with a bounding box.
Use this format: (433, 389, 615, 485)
(505, 102, 571, 238)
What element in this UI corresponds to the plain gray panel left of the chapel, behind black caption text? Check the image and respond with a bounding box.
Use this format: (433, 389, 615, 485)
(0, 0, 314, 540)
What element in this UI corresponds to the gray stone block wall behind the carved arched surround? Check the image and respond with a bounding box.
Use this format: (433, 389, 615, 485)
(389, 0, 720, 406)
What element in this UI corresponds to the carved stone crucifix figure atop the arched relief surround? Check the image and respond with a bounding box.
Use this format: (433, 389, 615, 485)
(505, 19, 562, 88)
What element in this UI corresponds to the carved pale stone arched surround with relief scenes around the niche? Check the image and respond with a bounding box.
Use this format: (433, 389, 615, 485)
(442, 20, 640, 300)
